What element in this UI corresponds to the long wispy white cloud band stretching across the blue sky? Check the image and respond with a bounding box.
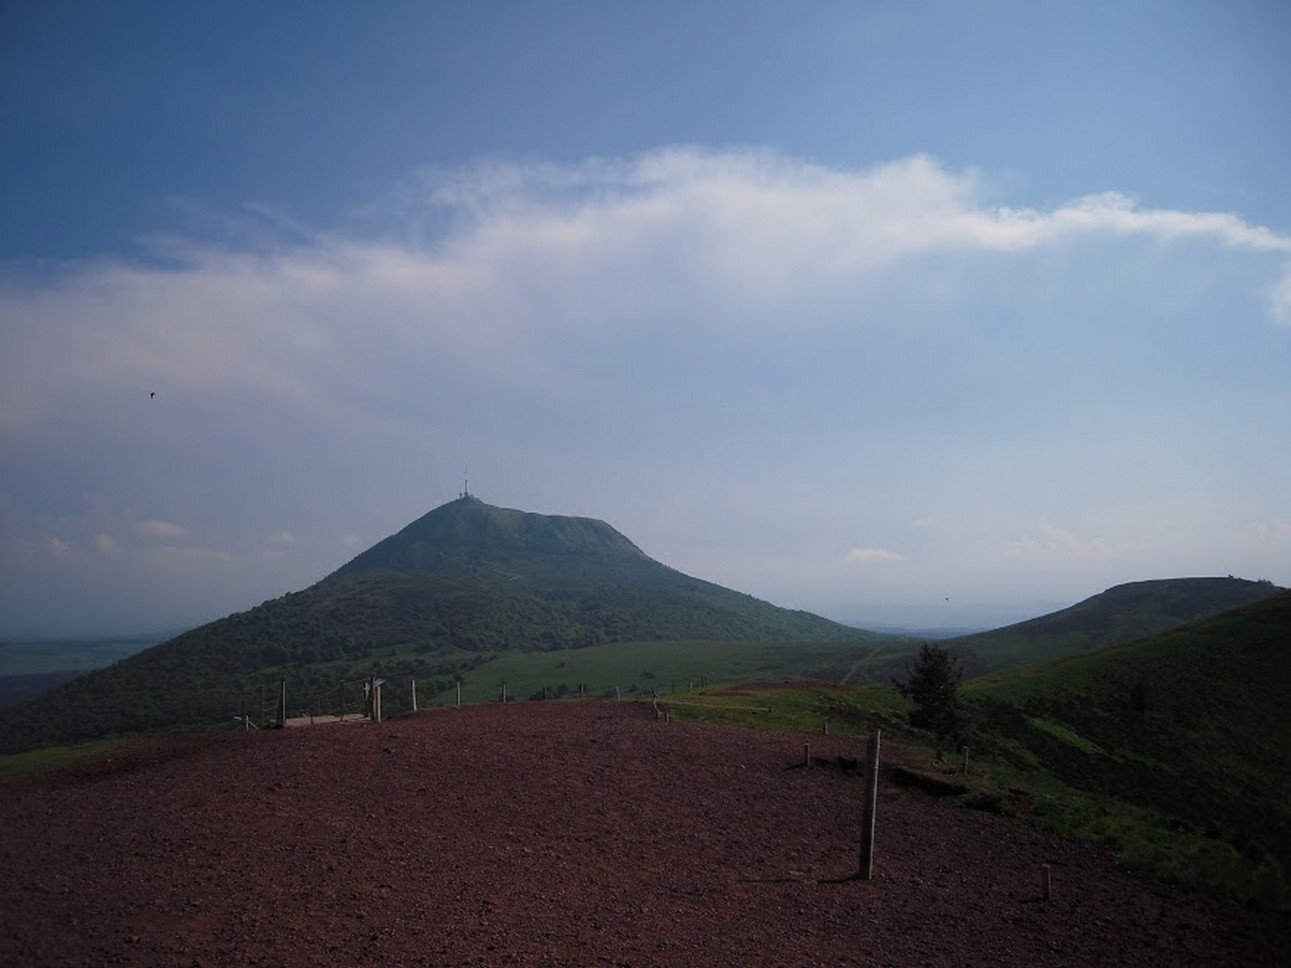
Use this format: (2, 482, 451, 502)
(0, 148, 1291, 443)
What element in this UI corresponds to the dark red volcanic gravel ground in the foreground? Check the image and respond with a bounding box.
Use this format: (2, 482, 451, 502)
(0, 701, 1288, 967)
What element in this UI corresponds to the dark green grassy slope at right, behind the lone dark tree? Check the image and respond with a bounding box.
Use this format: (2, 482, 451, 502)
(964, 586, 1291, 905)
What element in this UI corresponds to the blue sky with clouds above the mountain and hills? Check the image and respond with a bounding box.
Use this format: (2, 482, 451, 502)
(0, 0, 1291, 638)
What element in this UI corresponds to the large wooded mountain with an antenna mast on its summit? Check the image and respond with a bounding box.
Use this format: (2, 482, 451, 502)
(0, 496, 888, 751)
